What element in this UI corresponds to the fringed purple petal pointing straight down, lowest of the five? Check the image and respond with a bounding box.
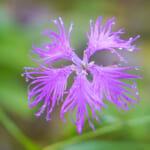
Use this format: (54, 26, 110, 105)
(60, 73, 106, 133)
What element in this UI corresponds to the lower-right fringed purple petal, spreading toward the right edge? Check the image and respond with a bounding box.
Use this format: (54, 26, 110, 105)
(90, 65, 141, 110)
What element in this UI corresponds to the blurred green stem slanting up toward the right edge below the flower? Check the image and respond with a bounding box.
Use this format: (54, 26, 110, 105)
(43, 116, 150, 150)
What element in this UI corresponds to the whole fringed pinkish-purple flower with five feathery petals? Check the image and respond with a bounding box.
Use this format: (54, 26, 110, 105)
(24, 17, 141, 133)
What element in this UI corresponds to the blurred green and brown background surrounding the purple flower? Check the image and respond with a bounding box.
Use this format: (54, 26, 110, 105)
(0, 0, 150, 150)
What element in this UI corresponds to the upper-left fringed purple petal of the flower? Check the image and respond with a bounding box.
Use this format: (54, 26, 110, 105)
(30, 17, 74, 64)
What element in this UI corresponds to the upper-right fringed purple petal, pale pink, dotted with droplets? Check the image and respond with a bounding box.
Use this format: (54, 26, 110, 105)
(85, 17, 140, 61)
